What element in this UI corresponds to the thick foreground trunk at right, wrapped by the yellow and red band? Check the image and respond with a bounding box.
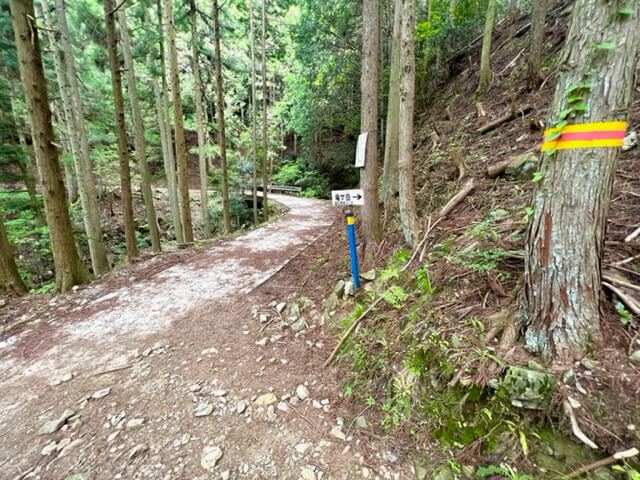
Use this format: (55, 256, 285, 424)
(520, 0, 640, 360)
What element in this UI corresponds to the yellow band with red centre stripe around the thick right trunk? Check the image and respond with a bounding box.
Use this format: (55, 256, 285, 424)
(540, 122, 627, 152)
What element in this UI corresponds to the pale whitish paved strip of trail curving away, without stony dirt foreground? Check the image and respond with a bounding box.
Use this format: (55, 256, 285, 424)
(0, 195, 335, 382)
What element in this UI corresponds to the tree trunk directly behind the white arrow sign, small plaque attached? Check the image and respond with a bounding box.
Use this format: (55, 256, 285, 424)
(360, 0, 382, 261)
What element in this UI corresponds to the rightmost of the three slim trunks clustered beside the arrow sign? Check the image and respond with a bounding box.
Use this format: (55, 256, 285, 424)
(398, 0, 418, 245)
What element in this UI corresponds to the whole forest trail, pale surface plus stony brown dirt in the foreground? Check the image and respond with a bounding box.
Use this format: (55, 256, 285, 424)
(0, 196, 411, 480)
